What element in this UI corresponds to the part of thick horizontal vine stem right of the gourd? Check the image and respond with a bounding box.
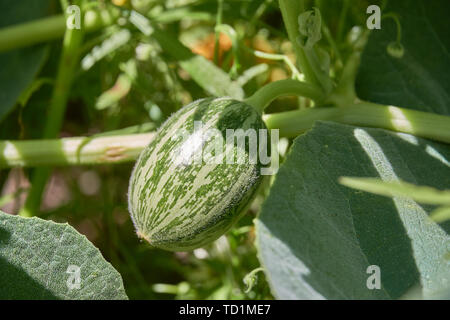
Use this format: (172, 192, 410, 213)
(263, 102, 450, 143)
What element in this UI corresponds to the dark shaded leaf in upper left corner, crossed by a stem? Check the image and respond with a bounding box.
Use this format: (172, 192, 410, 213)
(0, 0, 51, 121)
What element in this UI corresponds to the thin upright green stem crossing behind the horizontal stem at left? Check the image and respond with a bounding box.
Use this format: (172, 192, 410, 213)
(19, 9, 83, 217)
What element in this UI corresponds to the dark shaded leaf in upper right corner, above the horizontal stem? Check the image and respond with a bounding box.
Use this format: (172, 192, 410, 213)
(356, 0, 450, 115)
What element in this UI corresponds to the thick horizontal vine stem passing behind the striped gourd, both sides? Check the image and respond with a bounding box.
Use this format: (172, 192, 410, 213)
(0, 103, 450, 169)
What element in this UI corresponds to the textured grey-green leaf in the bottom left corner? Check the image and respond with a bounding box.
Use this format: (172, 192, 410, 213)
(0, 212, 127, 299)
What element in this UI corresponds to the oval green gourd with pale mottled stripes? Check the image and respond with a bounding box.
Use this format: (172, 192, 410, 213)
(128, 98, 266, 251)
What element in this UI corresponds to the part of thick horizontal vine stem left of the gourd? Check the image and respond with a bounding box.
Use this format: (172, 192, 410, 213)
(0, 132, 154, 169)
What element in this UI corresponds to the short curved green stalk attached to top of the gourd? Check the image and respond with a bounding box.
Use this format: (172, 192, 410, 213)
(244, 79, 324, 112)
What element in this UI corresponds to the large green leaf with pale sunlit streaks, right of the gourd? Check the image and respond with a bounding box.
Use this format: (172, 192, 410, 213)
(257, 122, 450, 299)
